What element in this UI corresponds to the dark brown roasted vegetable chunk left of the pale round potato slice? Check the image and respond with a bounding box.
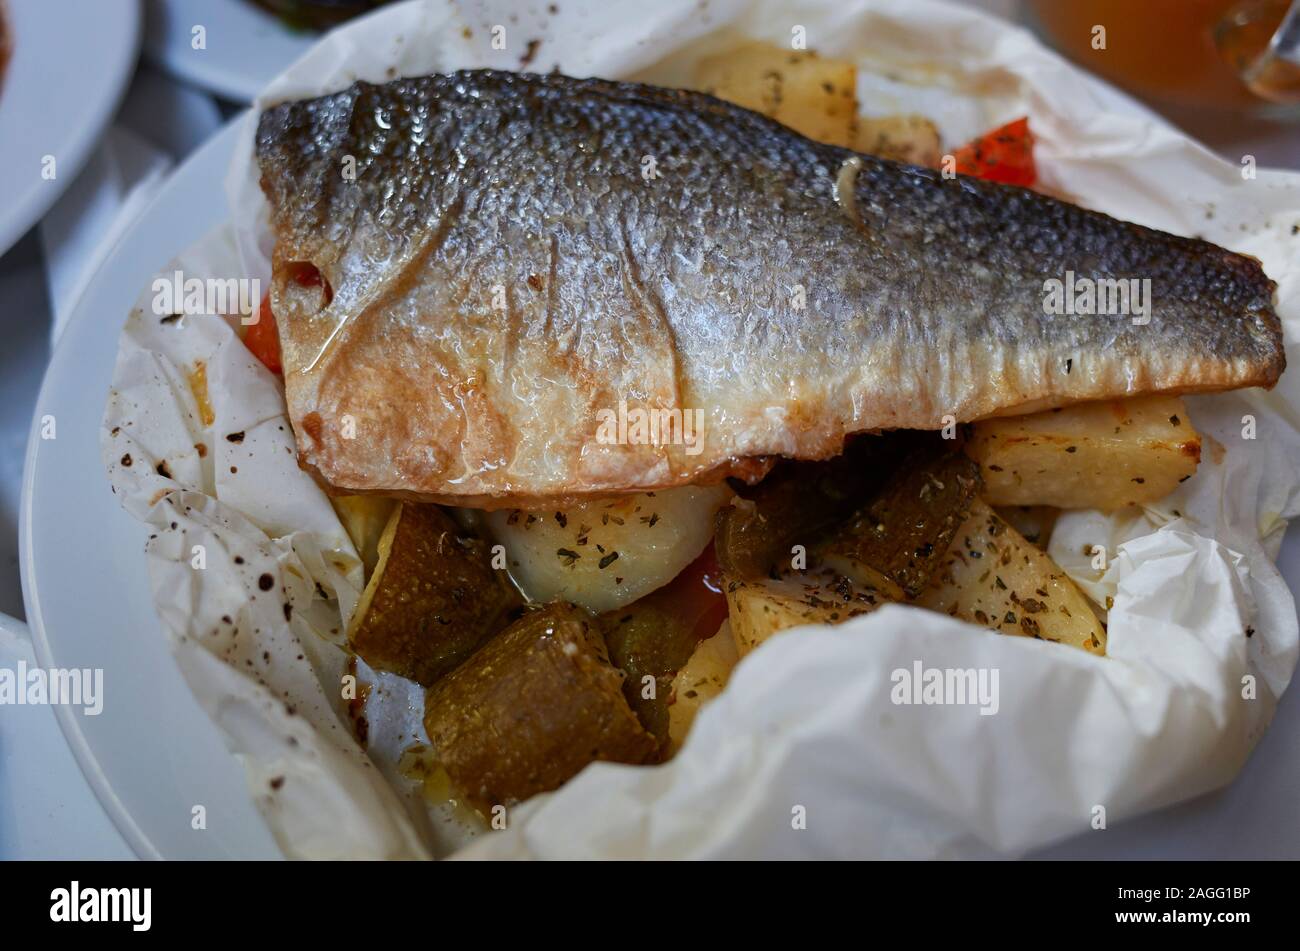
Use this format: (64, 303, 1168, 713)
(347, 503, 523, 686)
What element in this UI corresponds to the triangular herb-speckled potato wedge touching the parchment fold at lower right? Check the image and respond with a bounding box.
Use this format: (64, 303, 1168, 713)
(914, 499, 1106, 653)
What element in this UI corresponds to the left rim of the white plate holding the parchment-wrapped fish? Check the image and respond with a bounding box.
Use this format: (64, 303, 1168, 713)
(18, 125, 280, 859)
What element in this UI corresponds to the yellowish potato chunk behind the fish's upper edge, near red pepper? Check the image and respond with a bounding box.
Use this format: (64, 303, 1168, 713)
(693, 43, 858, 148)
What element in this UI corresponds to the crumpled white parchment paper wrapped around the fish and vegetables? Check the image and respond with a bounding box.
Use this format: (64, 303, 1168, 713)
(104, 0, 1300, 857)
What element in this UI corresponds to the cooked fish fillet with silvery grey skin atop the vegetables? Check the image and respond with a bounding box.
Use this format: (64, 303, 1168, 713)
(256, 70, 1284, 508)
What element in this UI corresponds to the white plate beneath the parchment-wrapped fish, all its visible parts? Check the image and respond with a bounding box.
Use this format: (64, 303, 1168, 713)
(21, 46, 1300, 859)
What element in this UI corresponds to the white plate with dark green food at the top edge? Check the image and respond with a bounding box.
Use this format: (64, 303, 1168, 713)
(144, 0, 319, 103)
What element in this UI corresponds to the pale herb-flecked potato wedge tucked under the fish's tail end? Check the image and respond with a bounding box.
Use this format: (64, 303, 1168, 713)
(966, 396, 1201, 511)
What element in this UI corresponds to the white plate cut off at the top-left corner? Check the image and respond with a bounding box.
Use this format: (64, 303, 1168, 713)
(0, 0, 140, 255)
